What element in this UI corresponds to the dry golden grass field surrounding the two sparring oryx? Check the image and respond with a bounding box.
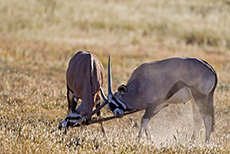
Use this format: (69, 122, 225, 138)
(0, 0, 230, 154)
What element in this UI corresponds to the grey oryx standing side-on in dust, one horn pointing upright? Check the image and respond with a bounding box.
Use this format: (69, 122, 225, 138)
(103, 58, 217, 142)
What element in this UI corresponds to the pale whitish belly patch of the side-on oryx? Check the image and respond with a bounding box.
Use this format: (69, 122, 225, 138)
(167, 87, 192, 104)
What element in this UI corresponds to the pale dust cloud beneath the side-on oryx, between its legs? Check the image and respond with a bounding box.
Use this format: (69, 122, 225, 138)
(142, 102, 204, 147)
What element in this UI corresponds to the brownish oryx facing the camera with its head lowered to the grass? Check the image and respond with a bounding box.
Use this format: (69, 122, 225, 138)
(59, 51, 104, 132)
